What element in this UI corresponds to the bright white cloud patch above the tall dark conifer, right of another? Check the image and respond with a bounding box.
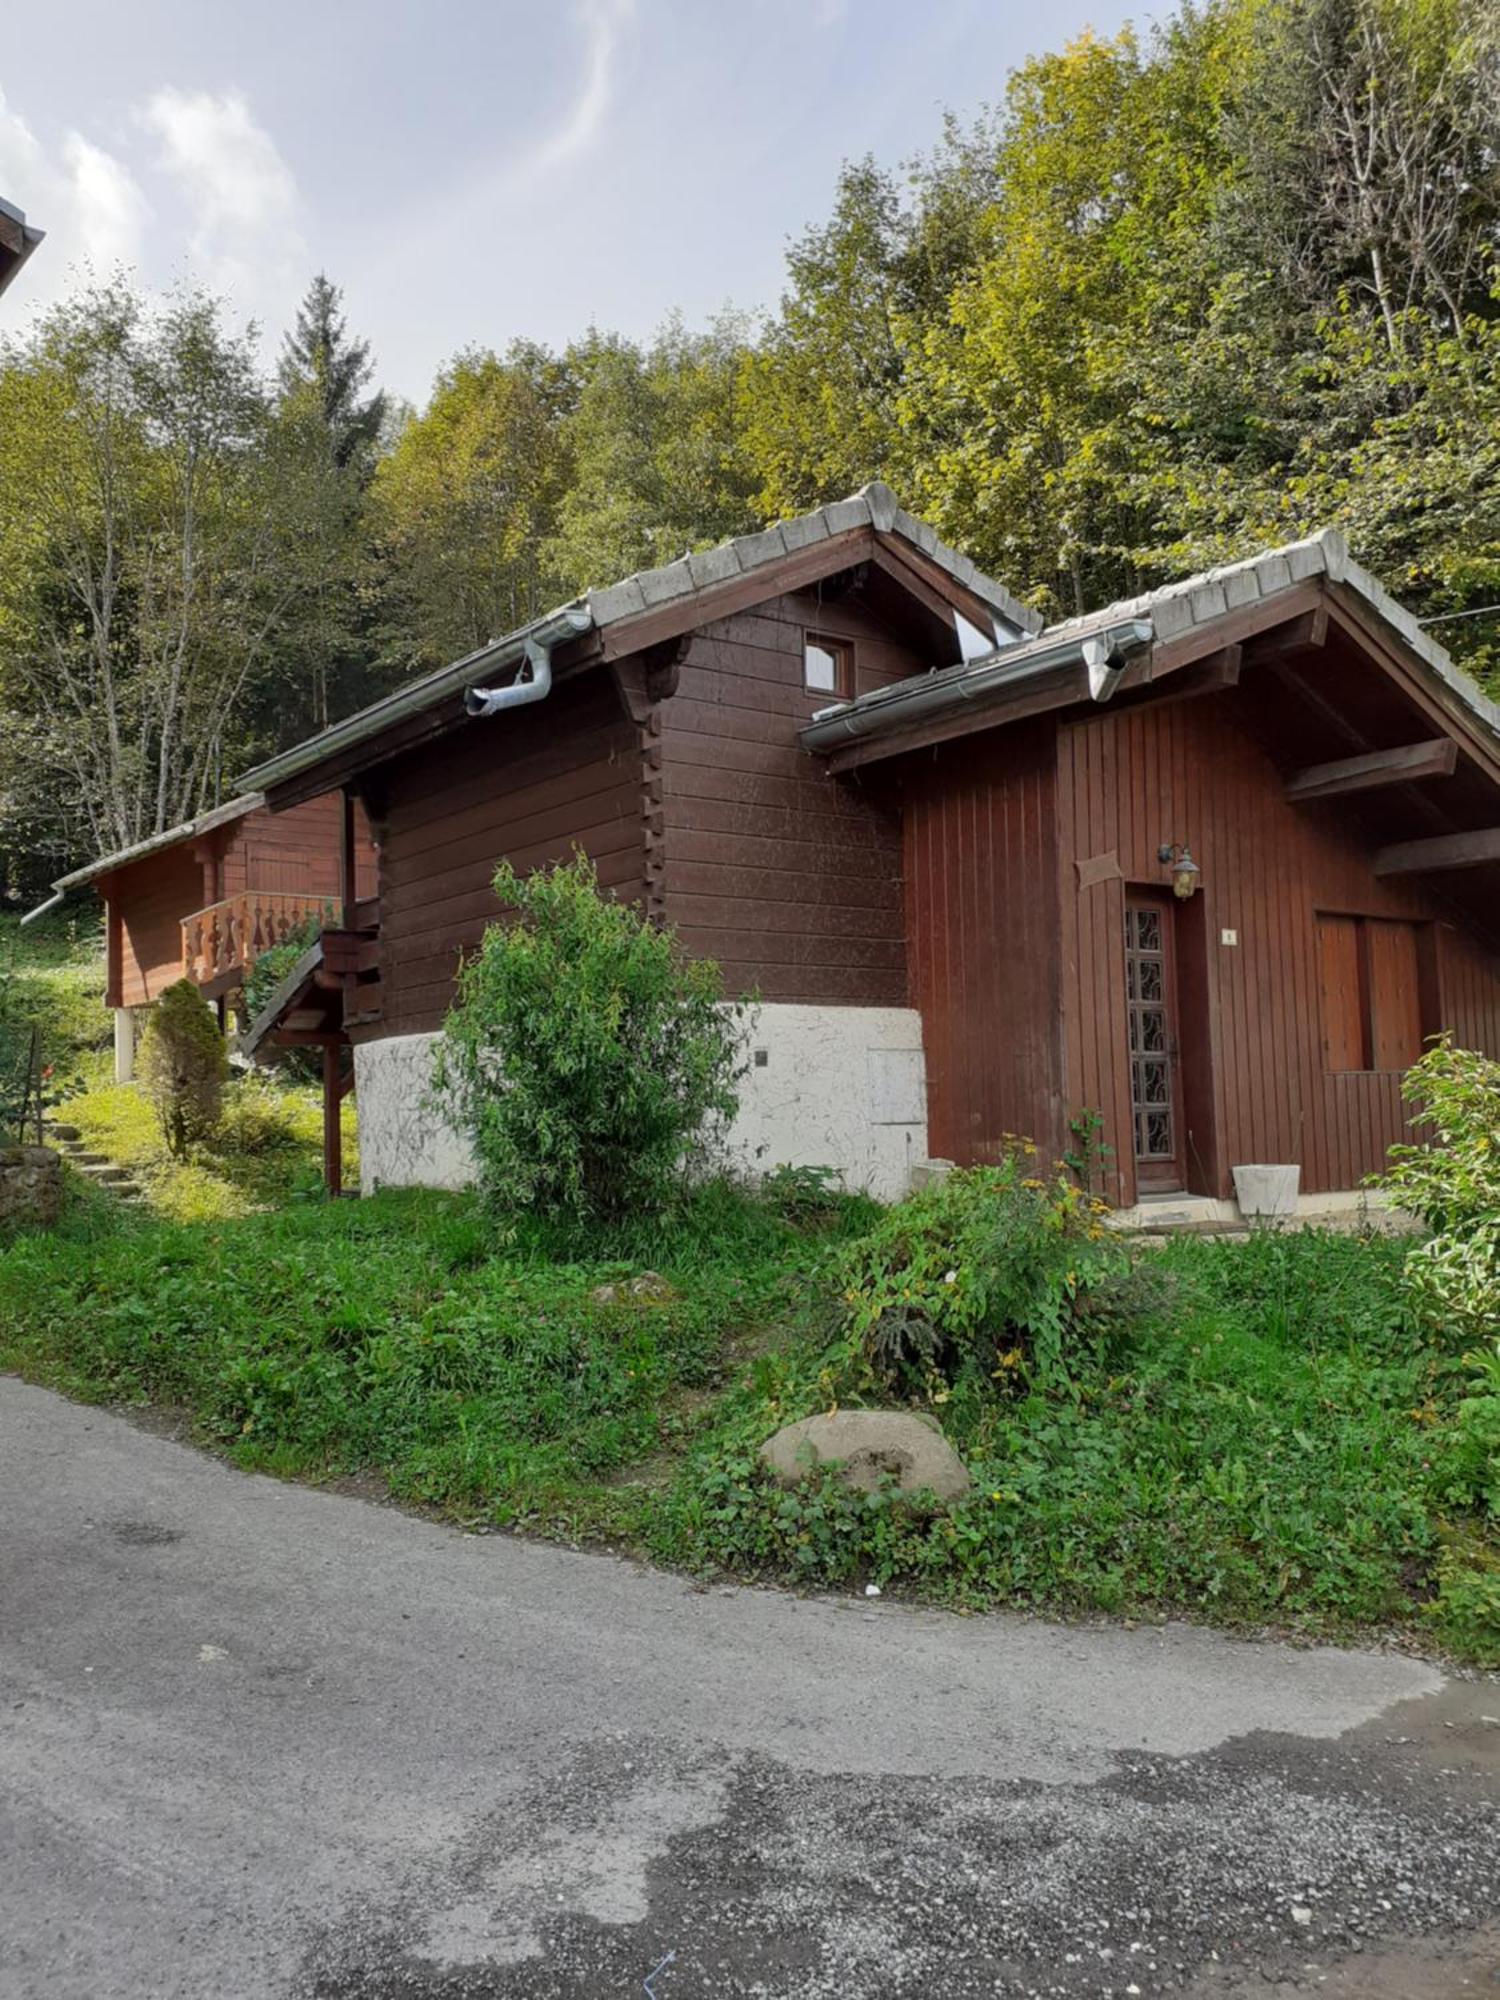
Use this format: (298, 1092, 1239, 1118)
(136, 86, 308, 318)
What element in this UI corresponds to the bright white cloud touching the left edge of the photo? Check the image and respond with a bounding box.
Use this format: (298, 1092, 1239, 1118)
(0, 94, 150, 308)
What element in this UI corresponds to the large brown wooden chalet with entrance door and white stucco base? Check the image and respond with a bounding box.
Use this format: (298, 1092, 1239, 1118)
(246, 486, 1500, 1204)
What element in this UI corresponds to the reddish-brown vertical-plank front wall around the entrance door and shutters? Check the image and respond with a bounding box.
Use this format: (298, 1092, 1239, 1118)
(1058, 690, 1500, 1202)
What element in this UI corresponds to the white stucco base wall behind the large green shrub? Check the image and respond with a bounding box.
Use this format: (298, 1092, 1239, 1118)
(354, 1006, 928, 1200)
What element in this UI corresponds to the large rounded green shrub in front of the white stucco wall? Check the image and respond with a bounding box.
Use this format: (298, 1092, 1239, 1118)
(434, 854, 740, 1220)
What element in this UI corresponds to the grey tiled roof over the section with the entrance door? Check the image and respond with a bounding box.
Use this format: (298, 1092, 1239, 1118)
(802, 528, 1500, 750)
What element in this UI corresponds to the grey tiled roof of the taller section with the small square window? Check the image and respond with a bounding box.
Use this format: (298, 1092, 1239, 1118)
(244, 482, 1042, 790)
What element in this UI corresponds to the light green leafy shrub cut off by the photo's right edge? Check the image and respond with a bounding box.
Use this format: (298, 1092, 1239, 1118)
(1384, 1036, 1500, 1342)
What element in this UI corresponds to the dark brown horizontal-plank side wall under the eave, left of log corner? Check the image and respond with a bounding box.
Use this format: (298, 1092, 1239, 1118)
(372, 672, 644, 1034)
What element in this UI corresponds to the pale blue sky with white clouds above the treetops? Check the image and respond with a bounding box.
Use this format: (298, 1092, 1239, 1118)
(0, 0, 1152, 404)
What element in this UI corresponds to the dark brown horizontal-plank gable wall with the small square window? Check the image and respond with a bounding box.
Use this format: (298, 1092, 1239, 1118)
(660, 592, 930, 1006)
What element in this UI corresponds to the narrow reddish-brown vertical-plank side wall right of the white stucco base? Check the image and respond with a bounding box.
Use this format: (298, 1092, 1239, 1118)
(902, 720, 1064, 1164)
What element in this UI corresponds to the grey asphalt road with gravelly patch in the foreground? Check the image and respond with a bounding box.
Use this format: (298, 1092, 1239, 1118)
(0, 1378, 1500, 2000)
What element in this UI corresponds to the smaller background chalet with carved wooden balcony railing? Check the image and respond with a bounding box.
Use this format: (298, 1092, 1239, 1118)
(54, 792, 374, 1082)
